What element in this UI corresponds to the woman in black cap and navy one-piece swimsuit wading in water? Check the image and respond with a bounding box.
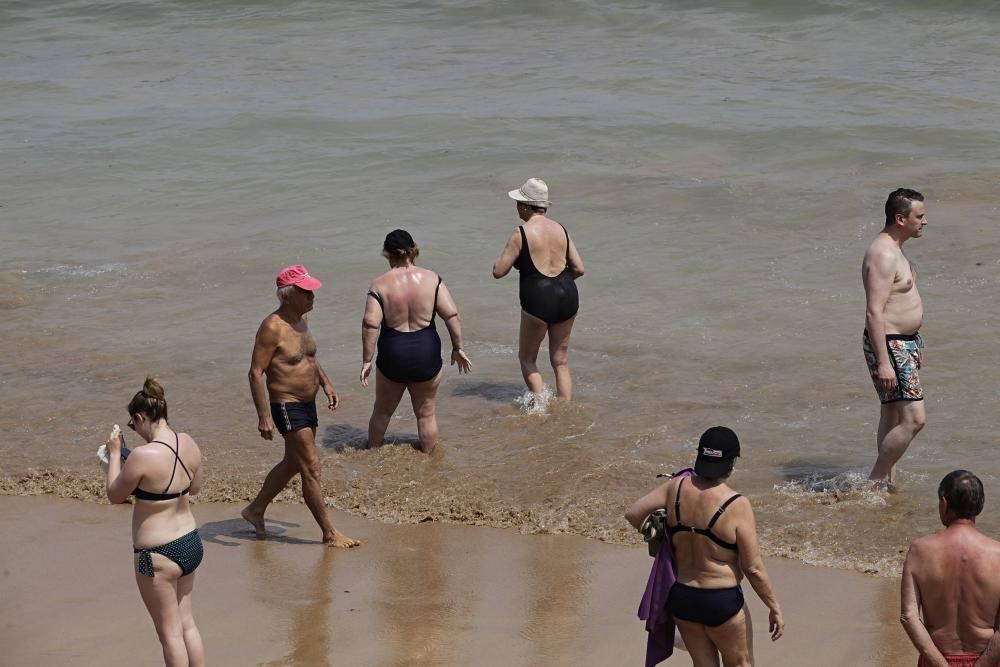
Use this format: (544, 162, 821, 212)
(361, 229, 472, 453)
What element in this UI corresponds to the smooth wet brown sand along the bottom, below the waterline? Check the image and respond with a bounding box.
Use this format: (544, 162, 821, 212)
(0, 496, 915, 667)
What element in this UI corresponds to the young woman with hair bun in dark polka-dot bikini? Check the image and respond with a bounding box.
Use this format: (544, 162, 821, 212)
(107, 378, 205, 667)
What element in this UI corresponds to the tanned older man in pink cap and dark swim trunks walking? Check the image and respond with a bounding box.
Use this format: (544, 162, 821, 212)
(241, 264, 361, 548)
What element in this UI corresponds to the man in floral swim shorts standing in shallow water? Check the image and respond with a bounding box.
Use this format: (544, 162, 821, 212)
(861, 188, 927, 487)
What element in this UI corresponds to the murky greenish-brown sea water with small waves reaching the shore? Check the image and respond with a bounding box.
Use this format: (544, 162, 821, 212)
(0, 0, 1000, 574)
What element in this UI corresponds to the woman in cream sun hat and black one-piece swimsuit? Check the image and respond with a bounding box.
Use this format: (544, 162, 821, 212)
(493, 178, 583, 400)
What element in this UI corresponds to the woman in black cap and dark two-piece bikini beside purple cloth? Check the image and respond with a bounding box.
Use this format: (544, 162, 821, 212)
(625, 426, 785, 667)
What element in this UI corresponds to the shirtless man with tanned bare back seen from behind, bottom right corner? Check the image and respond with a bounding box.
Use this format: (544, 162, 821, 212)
(900, 470, 1000, 667)
